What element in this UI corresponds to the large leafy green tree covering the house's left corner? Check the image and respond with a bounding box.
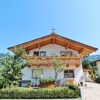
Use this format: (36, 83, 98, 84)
(0, 46, 27, 88)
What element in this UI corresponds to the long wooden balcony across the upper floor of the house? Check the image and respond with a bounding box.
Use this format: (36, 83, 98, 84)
(24, 56, 81, 67)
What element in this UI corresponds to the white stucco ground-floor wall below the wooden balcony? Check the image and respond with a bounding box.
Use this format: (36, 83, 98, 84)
(22, 66, 83, 83)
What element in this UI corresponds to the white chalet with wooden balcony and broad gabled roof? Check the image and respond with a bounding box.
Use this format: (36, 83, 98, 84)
(8, 32, 97, 84)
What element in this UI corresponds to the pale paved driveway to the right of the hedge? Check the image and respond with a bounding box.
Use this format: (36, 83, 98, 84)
(84, 82, 100, 100)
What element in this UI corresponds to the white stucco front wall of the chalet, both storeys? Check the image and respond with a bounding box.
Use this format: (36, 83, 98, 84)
(22, 44, 83, 83)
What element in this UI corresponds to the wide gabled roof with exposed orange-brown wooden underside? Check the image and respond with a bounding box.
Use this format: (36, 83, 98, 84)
(8, 33, 97, 57)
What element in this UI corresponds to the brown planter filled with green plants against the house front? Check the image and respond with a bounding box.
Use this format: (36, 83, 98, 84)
(39, 78, 55, 88)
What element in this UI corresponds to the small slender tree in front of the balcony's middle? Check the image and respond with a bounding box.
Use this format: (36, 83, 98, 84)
(52, 56, 64, 82)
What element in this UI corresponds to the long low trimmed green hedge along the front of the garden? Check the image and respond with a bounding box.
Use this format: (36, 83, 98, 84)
(0, 87, 80, 99)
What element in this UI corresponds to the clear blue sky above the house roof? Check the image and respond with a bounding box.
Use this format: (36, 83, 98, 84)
(0, 0, 100, 54)
